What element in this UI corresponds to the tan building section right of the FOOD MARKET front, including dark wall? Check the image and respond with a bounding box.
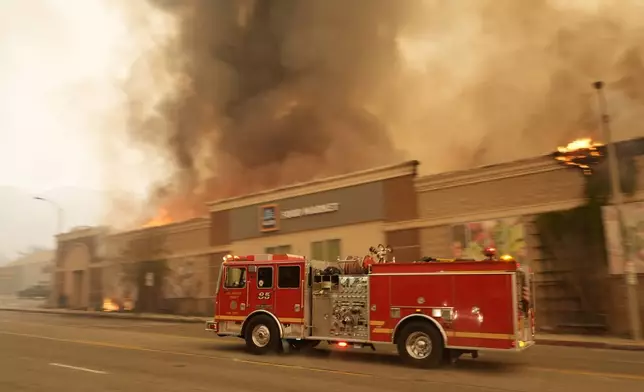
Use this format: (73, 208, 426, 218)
(385, 145, 644, 335)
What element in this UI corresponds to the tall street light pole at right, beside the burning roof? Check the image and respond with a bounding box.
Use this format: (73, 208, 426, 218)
(593, 81, 642, 340)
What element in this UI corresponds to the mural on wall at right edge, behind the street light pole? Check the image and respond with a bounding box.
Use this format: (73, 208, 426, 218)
(602, 202, 644, 275)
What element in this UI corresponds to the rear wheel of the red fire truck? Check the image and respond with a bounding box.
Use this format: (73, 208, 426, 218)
(396, 321, 444, 368)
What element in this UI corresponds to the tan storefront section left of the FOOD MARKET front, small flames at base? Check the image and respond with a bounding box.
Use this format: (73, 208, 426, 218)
(51, 218, 228, 314)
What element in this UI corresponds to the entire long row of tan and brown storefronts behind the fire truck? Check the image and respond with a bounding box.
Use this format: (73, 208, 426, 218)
(55, 142, 644, 334)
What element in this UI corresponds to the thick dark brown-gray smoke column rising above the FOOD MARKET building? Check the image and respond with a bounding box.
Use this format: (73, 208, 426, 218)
(126, 0, 406, 219)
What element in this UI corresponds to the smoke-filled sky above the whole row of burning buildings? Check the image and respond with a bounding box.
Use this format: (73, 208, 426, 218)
(0, 0, 644, 248)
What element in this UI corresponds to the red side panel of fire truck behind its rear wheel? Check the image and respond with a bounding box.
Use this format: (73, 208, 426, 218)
(448, 274, 514, 347)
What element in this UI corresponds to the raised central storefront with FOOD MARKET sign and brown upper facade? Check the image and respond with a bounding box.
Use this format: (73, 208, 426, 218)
(209, 161, 418, 260)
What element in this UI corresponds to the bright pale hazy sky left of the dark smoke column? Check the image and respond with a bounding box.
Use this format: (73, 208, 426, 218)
(0, 0, 176, 255)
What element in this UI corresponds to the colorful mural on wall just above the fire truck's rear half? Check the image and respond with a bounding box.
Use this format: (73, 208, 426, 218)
(452, 217, 527, 262)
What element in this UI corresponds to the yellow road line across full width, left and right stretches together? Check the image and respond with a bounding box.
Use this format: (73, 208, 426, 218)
(0, 331, 644, 381)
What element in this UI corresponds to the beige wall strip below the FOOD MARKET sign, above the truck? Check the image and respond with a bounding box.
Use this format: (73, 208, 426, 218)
(231, 222, 385, 257)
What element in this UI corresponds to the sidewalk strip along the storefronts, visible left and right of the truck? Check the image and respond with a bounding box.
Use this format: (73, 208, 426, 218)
(0, 307, 644, 351)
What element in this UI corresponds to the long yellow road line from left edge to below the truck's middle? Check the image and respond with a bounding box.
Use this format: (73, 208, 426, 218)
(0, 331, 374, 377)
